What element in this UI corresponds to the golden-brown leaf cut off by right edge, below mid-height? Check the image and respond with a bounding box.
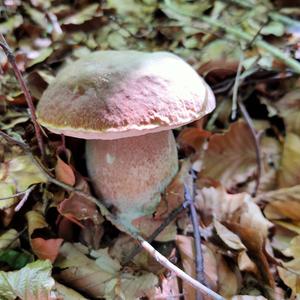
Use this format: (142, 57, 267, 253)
(257, 185, 300, 222)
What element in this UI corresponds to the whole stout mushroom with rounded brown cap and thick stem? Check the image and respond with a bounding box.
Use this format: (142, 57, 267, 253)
(37, 51, 215, 221)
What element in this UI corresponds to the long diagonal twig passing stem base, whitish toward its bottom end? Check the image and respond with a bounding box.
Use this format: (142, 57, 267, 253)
(0, 131, 224, 300)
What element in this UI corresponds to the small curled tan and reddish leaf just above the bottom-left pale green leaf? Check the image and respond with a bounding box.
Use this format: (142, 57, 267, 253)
(26, 210, 64, 262)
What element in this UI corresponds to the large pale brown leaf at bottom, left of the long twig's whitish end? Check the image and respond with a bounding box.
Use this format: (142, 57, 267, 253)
(56, 243, 158, 299)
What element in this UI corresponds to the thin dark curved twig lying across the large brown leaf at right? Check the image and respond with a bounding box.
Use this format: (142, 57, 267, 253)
(238, 101, 261, 197)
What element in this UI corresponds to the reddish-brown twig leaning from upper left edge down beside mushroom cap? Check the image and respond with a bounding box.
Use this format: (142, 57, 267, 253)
(0, 33, 45, 158)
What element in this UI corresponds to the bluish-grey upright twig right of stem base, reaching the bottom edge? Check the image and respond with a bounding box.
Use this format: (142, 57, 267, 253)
(184, 184, 205, 300)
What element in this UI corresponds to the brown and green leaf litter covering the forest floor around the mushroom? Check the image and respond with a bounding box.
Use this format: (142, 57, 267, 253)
(0, 0, 300, 300)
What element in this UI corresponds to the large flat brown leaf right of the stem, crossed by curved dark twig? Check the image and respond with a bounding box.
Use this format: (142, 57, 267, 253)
(200, 121, 281, 192)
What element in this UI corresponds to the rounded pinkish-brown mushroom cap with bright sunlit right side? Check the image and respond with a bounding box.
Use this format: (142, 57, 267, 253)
(37, 51, 215, 140)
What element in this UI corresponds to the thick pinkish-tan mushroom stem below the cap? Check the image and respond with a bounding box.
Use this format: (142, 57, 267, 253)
(86, 130, 178, 220)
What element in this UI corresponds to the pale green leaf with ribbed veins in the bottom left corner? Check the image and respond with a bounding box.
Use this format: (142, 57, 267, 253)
(0, 260, 55, 300)
